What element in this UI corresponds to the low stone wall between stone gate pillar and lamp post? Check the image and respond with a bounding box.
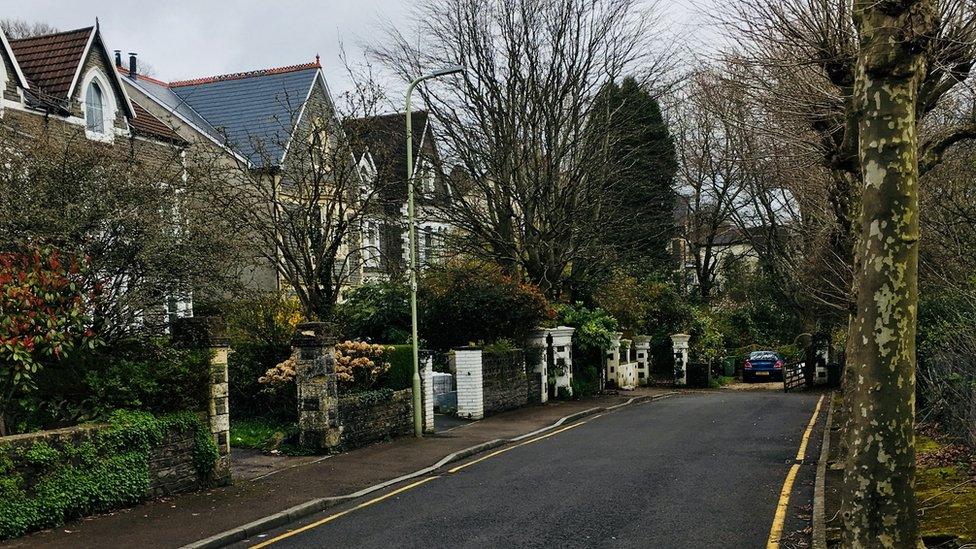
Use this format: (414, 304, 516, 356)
(337, 389, 413, 448)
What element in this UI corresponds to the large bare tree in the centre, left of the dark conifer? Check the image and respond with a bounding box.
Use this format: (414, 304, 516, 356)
(373, 0, 680, 296)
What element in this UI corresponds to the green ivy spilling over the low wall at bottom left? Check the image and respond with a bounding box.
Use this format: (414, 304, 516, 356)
(0, 410, 219, 539)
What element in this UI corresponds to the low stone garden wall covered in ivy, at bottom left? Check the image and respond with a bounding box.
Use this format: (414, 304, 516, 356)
(0, 412, 223, 539)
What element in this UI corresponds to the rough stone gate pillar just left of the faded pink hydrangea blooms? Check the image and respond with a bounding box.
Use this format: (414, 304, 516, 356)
(289, 322, 341, 450)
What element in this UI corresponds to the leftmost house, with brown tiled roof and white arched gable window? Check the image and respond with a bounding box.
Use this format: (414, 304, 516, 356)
(0, 24, 193, 322)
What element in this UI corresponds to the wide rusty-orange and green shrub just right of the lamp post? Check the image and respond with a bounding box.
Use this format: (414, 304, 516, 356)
(420, 263, 554, 350)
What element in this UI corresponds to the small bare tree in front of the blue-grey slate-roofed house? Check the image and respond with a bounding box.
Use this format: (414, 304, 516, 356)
(195, 70, 381, 320)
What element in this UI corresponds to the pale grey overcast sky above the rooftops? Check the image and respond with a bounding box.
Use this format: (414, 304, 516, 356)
(0, 0, 712, 103)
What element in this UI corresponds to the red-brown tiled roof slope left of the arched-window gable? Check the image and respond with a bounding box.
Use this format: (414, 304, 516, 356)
(10, 27, 95, 100)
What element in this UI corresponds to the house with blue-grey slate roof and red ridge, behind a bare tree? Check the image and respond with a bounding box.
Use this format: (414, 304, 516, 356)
(117, 57, 362, 300)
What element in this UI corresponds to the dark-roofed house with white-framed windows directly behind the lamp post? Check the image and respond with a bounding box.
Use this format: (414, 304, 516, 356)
(344, 111, 452, 280)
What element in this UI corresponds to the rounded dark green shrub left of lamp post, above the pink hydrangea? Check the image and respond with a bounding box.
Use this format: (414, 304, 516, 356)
(336, 282, 410, 343)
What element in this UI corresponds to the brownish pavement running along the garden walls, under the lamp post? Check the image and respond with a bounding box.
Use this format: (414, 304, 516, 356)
(0, 389, 667, 549)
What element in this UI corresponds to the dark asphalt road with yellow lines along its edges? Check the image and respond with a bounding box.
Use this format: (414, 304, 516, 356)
(242, 391, 823, 549)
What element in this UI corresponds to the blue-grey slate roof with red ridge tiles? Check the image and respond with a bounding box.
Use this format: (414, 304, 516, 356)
(147, 61, 320, 167)
